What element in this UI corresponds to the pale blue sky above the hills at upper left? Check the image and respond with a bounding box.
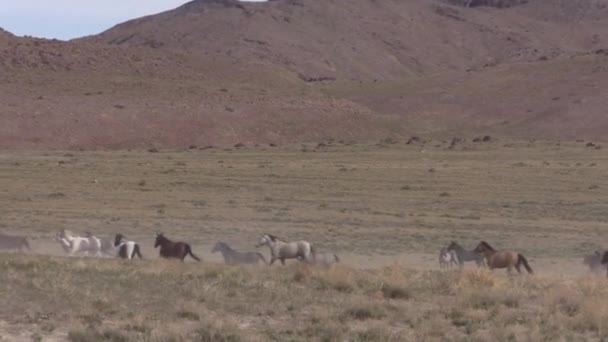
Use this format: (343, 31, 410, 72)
(0, 0, 260, 40)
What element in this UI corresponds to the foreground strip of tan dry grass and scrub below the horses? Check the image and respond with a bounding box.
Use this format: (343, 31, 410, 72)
(0, 255, 608, 341)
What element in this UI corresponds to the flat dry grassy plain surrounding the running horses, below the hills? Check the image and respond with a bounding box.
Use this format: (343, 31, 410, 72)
(0, 141, 608, 341)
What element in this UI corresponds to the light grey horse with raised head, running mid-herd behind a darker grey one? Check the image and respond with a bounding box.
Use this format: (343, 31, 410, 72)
(255, 234, 315, 265)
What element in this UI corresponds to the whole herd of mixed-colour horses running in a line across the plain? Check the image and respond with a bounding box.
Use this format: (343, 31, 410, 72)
(0, 229, 608, 276)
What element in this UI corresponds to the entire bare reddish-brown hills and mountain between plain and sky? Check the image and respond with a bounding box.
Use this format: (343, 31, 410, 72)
(0, 0, 608, 149)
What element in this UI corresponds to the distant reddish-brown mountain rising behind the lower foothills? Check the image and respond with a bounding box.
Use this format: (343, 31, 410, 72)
(85, 0, 608, 80)
